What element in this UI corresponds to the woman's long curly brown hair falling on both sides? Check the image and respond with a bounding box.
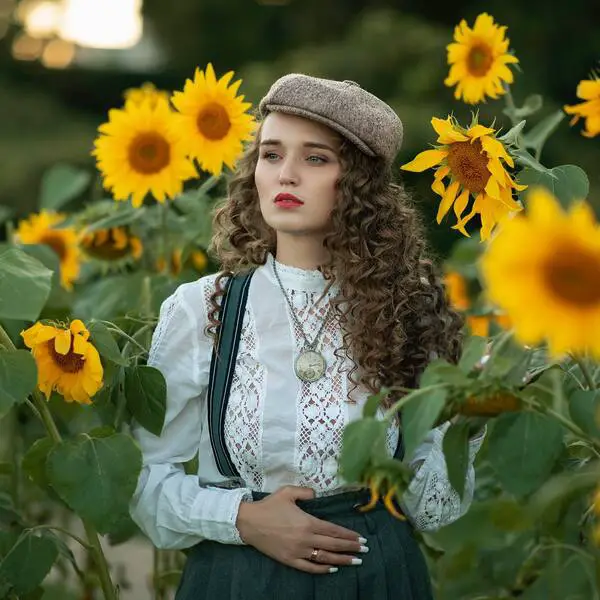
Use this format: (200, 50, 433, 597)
(206, 120, 463, 405)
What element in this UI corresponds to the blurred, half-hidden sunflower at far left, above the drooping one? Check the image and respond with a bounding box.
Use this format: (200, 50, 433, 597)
(15, 211, 81, 290)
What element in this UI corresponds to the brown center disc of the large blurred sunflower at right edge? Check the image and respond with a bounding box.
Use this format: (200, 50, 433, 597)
(545, 248, 600, 308)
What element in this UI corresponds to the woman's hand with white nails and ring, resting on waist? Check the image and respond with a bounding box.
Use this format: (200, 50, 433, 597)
(236, 485, 369, 574)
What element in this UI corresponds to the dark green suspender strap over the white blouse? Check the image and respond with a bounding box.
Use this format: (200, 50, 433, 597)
(207, 271, 254, 477)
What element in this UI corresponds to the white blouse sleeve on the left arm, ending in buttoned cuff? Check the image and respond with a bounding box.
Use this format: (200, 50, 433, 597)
(130, 280, 251, 549)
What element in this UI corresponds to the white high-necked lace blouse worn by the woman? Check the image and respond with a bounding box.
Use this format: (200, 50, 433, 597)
(130, 257, 483, 548)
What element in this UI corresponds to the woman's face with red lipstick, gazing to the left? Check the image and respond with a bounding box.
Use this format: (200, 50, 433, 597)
(254, 112, 341, 237)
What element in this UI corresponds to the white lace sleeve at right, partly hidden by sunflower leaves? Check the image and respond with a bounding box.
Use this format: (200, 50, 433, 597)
(402, 423, 486, 531)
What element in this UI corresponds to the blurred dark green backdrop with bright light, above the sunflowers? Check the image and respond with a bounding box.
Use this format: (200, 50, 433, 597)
(0, 0, 600, 253)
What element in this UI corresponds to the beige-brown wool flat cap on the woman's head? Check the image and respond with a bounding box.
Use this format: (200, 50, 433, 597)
(258, 73, 403, 165)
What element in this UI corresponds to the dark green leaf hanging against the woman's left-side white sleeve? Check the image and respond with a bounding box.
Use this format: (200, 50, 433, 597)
(125, 366, 167, 435)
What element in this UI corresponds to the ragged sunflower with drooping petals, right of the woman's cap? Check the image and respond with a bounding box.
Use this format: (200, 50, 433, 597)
(401, 116, 527, 241)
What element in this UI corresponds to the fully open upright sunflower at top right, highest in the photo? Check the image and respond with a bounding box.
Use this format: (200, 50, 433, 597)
(444, 13, 519, 104)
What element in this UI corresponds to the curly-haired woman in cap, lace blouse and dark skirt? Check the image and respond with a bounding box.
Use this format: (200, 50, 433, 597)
(132, 74, 482, 600)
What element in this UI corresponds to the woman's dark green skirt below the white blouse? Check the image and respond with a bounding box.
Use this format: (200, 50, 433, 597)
(175, 491, 433, 600)
